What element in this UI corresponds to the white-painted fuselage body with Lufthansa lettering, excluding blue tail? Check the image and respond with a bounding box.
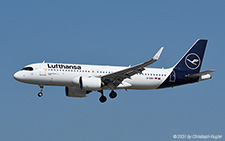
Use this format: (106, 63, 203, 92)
(14, 63, 173, 90)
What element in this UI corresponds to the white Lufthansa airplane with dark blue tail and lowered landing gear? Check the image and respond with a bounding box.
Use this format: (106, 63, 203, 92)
(14, 39, 215, 103)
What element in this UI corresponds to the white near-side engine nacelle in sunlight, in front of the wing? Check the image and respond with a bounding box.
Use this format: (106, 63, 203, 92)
(73, 76, 102, 90)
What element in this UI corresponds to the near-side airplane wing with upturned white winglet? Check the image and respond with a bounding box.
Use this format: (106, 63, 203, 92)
(101, 47, 164, 89)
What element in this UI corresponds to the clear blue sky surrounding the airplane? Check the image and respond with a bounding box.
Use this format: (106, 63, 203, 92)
(0, 0, 225, 141)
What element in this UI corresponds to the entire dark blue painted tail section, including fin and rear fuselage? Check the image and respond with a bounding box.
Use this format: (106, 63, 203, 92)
(159, 39, 207, 88)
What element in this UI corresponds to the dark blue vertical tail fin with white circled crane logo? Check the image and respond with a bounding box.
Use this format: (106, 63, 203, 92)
(174, 39, 207, 74)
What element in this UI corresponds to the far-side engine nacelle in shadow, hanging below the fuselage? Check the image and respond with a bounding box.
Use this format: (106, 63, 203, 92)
(65, 87, 91, 97)
